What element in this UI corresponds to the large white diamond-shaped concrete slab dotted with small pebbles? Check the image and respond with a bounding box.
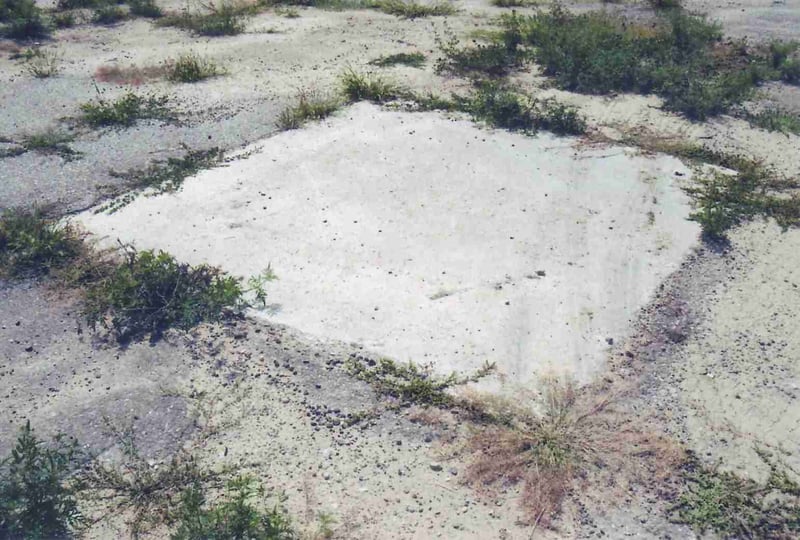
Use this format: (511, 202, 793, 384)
(80, 104, 698, 383)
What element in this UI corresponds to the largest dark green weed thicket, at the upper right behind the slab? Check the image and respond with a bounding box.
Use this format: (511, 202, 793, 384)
(488, 6, 793, 120)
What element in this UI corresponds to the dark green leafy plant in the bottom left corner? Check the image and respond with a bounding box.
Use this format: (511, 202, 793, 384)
(0, 422, 83, 539)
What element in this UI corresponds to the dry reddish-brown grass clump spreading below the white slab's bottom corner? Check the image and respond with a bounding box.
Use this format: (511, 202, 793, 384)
(465, 379, 683, 527)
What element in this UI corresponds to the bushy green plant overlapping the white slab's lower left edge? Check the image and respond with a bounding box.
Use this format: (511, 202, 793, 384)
(84, 248, 244, 342)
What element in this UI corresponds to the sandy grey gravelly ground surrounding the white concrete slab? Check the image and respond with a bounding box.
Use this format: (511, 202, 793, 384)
(0, 0, 800, 539)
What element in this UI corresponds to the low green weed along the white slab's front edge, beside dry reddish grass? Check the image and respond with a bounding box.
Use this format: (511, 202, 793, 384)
(345, 357, 495, 407)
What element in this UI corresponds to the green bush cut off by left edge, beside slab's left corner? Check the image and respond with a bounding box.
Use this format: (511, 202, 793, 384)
(0, 209, 83, 278)
